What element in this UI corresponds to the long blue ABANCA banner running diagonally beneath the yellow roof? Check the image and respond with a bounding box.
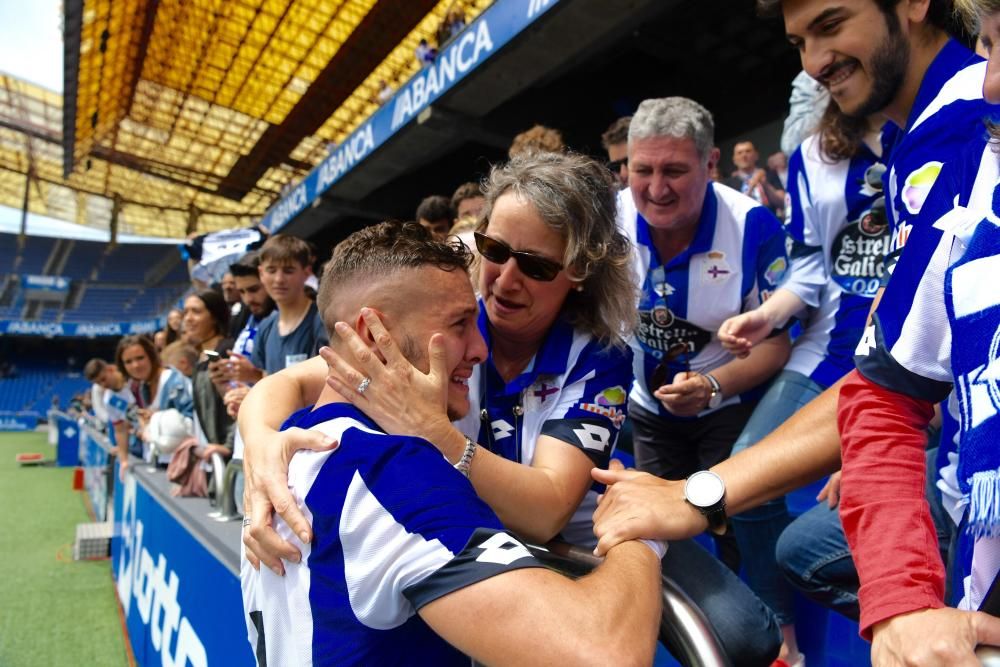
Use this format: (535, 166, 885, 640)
(261, 0, 559, 234)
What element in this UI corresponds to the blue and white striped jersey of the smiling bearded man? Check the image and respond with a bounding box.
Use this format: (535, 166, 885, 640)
(882, 39, 991, 266)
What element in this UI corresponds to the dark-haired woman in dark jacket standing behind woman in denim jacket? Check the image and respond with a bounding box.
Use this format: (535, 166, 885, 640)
(184, 289, 233, 459)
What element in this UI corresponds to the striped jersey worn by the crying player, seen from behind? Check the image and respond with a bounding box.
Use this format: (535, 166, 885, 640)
(241, 403, 541, 667)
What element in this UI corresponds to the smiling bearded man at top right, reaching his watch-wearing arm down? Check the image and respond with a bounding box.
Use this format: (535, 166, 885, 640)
(595, 0, 988, 660)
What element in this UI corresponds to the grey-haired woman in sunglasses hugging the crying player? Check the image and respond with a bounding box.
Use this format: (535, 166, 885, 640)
(240, 154, 777, 664)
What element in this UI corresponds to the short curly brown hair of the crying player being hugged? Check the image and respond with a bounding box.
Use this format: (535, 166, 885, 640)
(316, 220, 472, 340)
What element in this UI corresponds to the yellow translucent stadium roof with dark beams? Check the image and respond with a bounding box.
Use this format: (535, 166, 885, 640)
(0, 0, 491, 237)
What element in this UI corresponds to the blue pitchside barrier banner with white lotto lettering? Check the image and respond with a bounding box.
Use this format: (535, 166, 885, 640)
(111, 473, 254, 667)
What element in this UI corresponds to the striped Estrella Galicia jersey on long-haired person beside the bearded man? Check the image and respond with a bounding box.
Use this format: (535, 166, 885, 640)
(782, 135, 889, 387)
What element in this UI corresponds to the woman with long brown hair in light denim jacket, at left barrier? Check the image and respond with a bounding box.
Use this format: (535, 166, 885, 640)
(115, 335, 194, 471)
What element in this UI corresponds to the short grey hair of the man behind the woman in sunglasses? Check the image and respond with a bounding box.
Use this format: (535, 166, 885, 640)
(628, 97, 715, 160)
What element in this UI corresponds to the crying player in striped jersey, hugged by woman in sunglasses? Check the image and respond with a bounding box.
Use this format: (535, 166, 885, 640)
(242, 223, 660, 665)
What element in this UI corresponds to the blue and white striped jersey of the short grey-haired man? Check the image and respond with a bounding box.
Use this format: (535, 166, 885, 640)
(618, 183, 788, 419)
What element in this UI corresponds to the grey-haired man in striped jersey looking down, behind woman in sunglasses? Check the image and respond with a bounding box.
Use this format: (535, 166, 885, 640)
(619, 97, 790, 665)
